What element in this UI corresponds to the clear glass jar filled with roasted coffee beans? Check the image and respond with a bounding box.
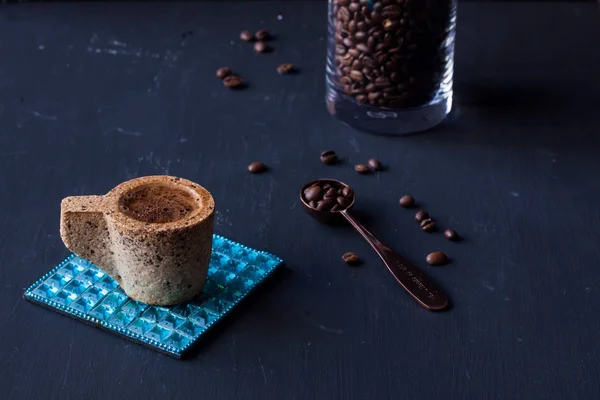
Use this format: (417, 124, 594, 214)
(326, 0, 456, 134)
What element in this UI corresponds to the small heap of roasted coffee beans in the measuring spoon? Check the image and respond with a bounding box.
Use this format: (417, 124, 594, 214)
(302, 181, 354, 212)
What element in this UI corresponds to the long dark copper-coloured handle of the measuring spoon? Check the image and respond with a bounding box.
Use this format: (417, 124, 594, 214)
(340, 210, 448, 310)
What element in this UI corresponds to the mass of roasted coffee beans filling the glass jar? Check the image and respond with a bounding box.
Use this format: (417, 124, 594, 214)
(330, 0, 454, 108)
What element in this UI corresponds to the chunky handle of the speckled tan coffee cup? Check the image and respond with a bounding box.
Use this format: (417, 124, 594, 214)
(60, 196, 120, 283)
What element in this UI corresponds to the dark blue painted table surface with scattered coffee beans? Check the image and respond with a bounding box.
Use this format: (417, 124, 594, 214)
(0, 1, 600, 400)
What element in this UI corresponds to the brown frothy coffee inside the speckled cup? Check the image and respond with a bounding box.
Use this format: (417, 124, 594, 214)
(119, 183, 200, 224)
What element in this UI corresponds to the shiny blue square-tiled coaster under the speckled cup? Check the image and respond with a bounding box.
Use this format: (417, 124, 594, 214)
(25, 235, 283, 358)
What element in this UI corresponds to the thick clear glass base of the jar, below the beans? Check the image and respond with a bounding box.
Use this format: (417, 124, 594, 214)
(326, 90, 452, 135)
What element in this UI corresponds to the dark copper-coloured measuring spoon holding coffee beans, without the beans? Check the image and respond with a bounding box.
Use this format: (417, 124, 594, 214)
(300, 179, 448, 310)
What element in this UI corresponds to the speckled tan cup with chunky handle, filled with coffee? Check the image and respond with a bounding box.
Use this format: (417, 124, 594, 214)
(60, 176, 215, 305)
